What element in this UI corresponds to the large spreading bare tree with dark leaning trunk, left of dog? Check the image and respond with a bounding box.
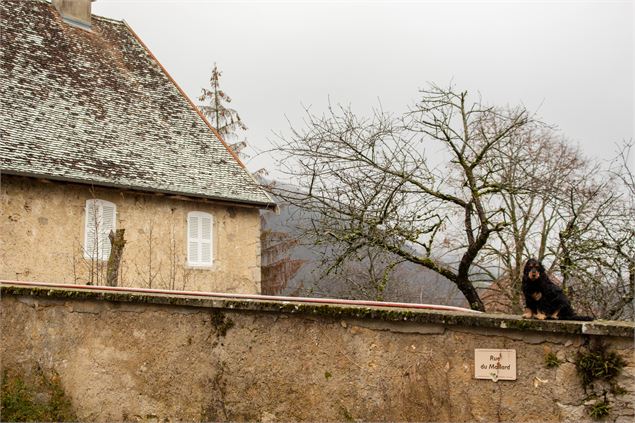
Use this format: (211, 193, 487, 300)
(277, 86, 530, 310)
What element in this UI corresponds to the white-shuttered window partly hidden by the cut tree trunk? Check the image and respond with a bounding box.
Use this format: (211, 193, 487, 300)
(84, 200, 117, 260)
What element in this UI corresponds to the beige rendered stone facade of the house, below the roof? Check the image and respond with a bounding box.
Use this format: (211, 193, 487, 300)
(0, 175, 260, 293)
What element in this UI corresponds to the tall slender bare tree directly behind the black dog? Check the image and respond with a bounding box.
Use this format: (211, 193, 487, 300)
(478, 124, 585, 312)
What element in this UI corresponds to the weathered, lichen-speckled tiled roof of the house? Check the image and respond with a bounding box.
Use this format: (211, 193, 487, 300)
(0, 0, 273, 206)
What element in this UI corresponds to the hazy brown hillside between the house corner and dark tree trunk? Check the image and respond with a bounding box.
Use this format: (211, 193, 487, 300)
(261, 177, 464, 305)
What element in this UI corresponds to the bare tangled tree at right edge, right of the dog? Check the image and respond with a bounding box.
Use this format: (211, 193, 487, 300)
(552, 143, 635, 319)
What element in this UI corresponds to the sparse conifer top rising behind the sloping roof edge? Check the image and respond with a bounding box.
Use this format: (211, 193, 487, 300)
(198, 63, 247, 154)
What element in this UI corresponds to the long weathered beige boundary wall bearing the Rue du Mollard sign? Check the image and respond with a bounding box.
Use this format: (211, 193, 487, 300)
(1, 284, 635, 422)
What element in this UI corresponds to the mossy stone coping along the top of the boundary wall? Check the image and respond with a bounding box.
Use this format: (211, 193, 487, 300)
(0, 282, 635, 338)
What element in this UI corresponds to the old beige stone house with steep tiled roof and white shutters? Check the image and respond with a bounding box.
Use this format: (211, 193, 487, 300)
(0, 0, 276, 293)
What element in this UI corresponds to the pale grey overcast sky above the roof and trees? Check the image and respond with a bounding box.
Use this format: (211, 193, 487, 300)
(93, 0, 635, 175)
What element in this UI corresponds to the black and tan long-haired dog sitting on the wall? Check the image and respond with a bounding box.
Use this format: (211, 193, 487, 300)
(522, 259, 593, 321)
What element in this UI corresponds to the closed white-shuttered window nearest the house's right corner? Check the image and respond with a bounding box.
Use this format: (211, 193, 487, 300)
(187, 212, 214, 267)
